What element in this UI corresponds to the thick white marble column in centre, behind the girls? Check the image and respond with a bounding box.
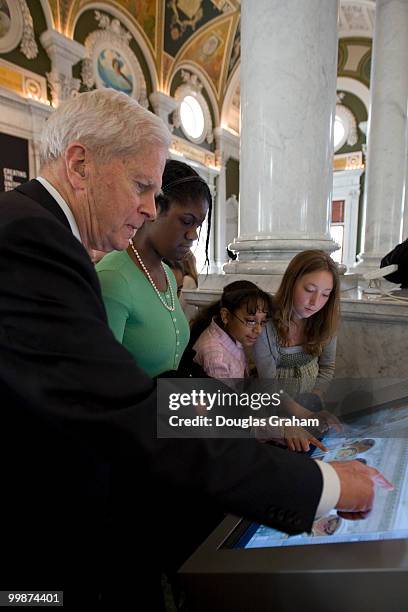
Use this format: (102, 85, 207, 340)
(224, 0, 338, 275)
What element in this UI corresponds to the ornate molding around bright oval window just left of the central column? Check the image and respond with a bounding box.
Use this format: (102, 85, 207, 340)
(173, 70, 214, 144)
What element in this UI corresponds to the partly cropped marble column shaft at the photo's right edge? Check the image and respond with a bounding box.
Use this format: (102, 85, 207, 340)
(355, 0, 408, 273)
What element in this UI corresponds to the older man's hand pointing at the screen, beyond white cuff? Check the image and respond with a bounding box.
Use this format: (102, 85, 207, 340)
(330, 461, 394, 520)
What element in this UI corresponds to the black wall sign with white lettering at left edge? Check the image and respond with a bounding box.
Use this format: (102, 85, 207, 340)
(0, 133, 29, 191)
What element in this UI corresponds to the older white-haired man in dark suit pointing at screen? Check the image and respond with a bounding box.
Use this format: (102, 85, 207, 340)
(0, 89, 390, 609)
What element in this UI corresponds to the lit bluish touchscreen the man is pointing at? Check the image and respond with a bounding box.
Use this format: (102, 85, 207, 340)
(234, 405, 408, 548)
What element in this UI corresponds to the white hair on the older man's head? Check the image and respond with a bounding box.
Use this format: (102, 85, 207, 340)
(40, 88, 171, 164)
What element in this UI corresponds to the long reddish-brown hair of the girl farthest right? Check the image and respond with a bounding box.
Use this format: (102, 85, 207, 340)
(273, 250, 340, 355)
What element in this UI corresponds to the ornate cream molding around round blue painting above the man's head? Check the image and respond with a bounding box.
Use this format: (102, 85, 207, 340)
(81, 11, 149, 108)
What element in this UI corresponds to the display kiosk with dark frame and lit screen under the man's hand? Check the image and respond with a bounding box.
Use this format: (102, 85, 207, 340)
(180, 388, 408, 612)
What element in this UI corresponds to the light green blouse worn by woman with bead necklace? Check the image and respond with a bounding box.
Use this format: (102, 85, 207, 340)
(96, 251, 190, 376)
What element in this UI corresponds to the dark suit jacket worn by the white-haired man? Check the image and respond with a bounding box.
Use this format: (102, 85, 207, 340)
(0, 180, 322, 604)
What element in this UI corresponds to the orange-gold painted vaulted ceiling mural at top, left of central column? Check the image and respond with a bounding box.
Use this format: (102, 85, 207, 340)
(48, 0, 240, 111)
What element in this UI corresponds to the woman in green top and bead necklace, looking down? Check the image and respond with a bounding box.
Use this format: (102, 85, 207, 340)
(96, 160, 212, 376)
